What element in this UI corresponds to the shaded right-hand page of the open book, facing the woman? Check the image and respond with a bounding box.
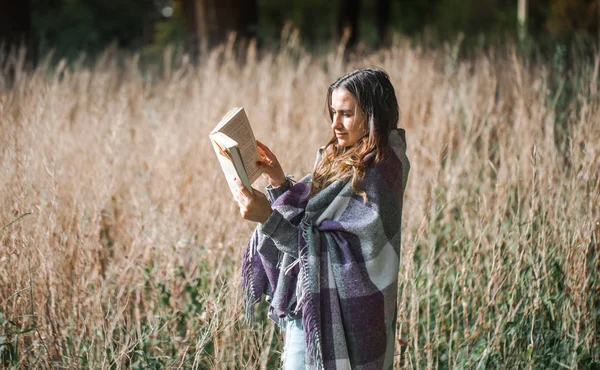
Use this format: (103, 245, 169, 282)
(219, 108, 261, 183)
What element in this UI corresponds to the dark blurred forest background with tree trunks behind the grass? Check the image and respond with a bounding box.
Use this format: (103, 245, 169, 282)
(0, 0, 600, 60)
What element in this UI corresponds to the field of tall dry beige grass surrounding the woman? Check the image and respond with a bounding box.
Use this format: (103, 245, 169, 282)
(0, 38, 600, 369)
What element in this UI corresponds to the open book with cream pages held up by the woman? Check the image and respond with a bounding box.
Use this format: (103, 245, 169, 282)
(209, 107, 261, 194)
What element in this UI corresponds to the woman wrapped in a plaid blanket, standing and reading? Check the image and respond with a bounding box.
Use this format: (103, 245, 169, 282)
(236, 69, 410, 369)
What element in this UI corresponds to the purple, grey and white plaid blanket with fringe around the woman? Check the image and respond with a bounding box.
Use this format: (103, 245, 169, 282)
(242, 130, 410, 369)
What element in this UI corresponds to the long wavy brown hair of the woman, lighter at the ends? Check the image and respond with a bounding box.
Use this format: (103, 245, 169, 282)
(311, 68, 400, 201)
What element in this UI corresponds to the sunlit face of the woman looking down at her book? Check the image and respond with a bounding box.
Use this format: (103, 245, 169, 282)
(330, 89, 367, 147)
